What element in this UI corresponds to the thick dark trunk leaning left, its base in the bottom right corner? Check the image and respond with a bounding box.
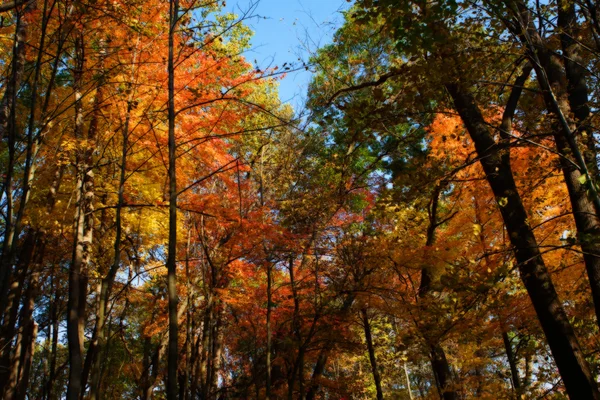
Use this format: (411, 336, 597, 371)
(446, 83, 600, 399)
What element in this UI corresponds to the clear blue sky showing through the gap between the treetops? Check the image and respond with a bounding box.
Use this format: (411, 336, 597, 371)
(227, 0, 350, 108)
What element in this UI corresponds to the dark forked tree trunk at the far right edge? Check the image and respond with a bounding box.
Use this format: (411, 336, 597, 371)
(506, 3, 600, 325)
